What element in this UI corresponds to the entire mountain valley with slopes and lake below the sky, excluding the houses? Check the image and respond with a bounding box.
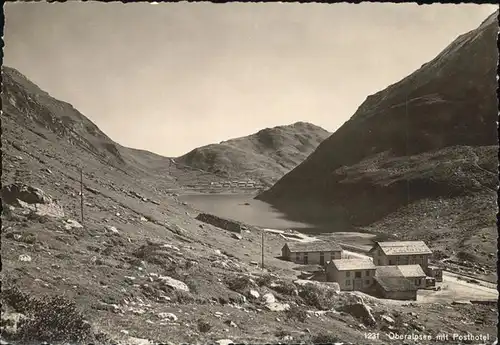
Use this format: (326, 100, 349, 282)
(1, 7, 498, 345)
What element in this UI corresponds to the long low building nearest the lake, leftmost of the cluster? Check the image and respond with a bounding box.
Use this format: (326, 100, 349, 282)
(281, 241, 342, 265)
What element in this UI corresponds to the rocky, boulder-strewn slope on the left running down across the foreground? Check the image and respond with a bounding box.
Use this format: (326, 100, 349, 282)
(1, 63, 496, 345)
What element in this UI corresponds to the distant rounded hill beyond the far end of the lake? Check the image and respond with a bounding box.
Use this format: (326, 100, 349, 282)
(176, 122, 331, 185)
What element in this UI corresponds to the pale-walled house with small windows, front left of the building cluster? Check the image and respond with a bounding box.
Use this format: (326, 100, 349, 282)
(326, 259, 375, 291)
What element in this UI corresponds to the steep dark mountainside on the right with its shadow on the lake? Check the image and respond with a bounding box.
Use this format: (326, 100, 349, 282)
(258, 13, 498, 272)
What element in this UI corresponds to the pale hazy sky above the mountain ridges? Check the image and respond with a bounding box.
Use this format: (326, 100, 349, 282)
(4, 2, 498, 156)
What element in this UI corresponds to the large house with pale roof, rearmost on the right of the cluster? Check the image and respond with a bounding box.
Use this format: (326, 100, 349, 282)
(370, 241, 432, 271)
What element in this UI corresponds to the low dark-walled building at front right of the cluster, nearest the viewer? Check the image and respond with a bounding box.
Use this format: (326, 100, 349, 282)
(373, 265, 425, 300)
